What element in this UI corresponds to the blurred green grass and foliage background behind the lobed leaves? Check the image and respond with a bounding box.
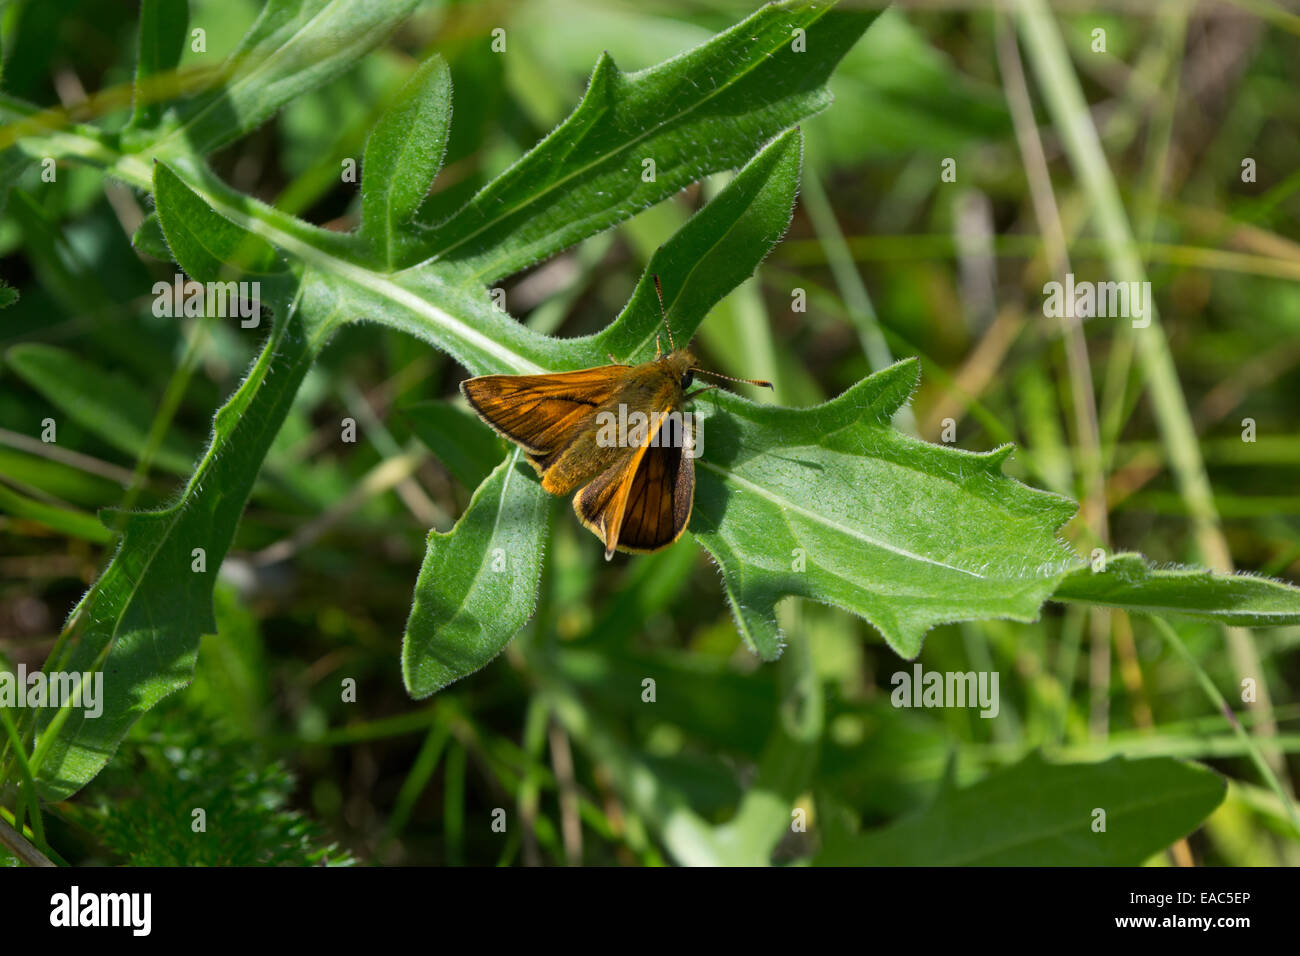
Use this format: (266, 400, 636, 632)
(0, 0, 1300, 865)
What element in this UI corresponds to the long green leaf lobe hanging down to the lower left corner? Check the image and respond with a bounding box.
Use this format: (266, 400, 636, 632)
(27, 284, 322, 800)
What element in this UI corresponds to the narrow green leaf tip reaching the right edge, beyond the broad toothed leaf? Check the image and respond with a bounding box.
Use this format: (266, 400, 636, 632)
(1052, 554, 1300, 627)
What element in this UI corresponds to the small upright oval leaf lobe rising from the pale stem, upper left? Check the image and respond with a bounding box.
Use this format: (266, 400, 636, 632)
(361, 56, 451, 268)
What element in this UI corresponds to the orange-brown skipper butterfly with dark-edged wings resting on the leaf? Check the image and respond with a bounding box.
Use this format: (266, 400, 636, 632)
(460, 276, 772, 561)
